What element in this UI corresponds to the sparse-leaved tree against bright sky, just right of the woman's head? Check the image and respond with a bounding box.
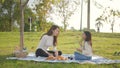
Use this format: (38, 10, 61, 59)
(55, 0, 79, 31)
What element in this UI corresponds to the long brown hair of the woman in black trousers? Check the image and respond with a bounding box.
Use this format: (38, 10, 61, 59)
(40, 25, 59, 46)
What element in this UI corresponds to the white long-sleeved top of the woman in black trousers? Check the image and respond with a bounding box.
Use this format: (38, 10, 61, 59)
(37, 35, 56, 51)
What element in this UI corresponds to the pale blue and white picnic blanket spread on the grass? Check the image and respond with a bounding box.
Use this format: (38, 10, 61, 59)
(7, 53, 120, 64)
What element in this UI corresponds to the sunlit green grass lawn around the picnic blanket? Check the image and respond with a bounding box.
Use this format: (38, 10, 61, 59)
(0, 32, 120, 68)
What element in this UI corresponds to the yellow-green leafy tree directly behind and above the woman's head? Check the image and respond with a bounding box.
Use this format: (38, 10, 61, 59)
(34, 0, 54, 31)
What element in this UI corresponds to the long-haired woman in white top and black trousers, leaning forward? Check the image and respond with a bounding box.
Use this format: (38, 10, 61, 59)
(36, 25, 62, 57)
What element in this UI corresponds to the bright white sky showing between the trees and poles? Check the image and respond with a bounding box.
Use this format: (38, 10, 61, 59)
(28, 0, 120, 33)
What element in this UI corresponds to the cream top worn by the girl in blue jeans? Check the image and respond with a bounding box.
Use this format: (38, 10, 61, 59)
(82, 41, 93, 56)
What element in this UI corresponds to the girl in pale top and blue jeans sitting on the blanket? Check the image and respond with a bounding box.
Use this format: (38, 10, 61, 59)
(74, 31, 92, 60)
